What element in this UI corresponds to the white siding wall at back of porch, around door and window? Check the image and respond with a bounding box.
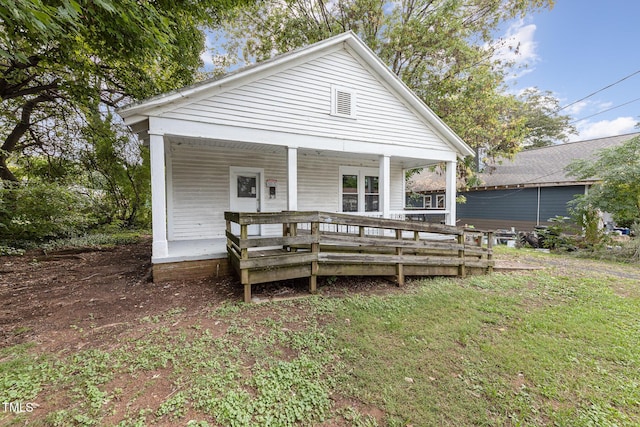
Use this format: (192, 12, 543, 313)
(167, 143, 404, 240)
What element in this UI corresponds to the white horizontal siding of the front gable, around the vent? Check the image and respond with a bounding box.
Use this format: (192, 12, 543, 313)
(161, 50, 451, 152)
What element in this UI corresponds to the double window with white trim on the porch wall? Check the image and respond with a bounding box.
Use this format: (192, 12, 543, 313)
(340, 166, 380, 212)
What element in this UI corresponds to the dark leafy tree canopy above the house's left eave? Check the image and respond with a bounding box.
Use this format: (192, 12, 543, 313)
(0, 0, 248, 181)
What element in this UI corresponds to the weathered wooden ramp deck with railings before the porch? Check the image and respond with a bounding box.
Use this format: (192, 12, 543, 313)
(225, 211, 494, 302)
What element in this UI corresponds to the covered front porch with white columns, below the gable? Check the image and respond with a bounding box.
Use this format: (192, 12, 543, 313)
(149, 134, 457, 264)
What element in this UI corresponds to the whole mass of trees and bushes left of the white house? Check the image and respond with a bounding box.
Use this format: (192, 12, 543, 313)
(0, 0, 249, 237)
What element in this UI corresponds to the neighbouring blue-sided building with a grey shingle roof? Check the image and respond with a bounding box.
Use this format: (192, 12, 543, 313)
(408, 133, 640, 231)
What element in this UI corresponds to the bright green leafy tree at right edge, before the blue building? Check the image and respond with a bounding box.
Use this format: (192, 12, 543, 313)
(567, 137, 640, 227)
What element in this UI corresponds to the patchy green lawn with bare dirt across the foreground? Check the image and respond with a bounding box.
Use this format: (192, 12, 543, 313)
(0, 252, 640, 426)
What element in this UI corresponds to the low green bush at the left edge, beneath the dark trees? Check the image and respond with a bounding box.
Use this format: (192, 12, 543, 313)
(0, 182, 96, 243)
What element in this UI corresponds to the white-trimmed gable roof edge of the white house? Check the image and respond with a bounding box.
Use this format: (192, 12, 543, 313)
(118, 31, 474, 156)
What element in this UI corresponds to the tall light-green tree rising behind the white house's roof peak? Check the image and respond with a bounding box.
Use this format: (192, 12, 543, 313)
(216, 0, 566, 168)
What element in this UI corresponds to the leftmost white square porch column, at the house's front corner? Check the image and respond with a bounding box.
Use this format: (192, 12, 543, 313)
(149, 133, 169, 259)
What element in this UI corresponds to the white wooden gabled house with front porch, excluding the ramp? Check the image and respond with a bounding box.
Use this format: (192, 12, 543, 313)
(119, 32, 473, 280)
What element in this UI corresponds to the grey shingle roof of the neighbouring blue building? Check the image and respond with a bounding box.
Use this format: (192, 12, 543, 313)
(410, 132, 640, 192)
